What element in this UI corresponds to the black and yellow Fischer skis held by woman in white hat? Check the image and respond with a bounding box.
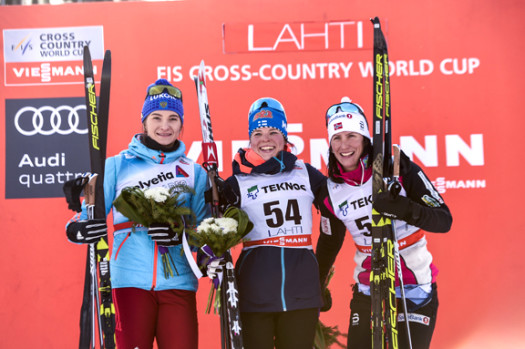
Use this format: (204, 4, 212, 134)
(370, 17, 412, 349)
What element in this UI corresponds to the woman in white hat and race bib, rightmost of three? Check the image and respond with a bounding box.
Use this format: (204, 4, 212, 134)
(316, 97, 452, 348)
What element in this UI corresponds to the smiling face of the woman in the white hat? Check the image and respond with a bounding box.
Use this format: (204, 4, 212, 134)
(330, 131, 364, 172)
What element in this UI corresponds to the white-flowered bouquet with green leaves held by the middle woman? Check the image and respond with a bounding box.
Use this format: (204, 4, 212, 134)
(190, 206, 253, 257)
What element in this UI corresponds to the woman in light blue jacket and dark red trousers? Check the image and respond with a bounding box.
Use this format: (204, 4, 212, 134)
(67, 79, 209, 349)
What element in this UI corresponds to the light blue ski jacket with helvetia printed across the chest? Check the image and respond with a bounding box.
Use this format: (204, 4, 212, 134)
(71, 134, 210, 291)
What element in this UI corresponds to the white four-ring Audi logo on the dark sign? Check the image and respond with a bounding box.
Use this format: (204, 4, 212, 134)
(15, 105, 88, 136)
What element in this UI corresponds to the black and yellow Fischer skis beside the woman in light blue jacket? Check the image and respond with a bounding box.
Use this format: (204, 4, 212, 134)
(64, 46, 116, 349)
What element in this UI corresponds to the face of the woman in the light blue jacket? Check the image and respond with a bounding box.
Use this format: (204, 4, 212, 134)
(143, 110, 182, 147)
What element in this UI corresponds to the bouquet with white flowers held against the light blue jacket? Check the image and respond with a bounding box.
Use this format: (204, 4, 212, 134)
(113, 184, 195, 234)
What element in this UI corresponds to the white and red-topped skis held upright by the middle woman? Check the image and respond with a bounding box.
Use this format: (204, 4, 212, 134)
(193, 61, 243, 349)
